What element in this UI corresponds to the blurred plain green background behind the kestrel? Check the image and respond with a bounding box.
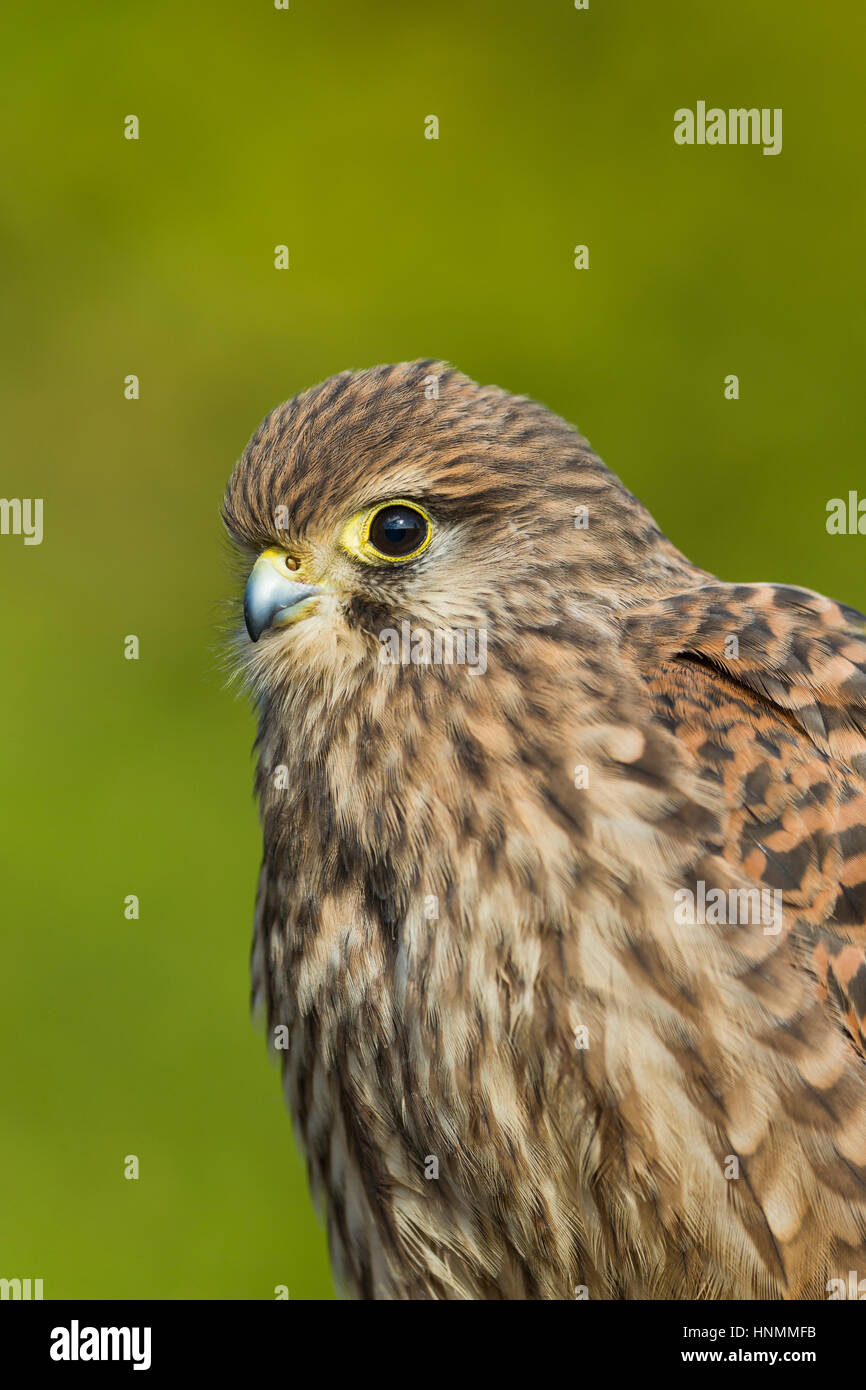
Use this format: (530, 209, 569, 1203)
(0, 0, 866, 1298)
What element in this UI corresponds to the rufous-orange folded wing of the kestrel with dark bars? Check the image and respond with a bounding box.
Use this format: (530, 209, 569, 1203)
(623, 582, 866, 1049)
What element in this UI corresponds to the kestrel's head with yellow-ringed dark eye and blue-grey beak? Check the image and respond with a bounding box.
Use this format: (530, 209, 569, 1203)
(224, 360, 697, 685)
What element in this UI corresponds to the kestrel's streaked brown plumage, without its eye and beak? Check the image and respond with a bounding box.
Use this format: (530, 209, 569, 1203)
(225, 361, 866, 1298)
